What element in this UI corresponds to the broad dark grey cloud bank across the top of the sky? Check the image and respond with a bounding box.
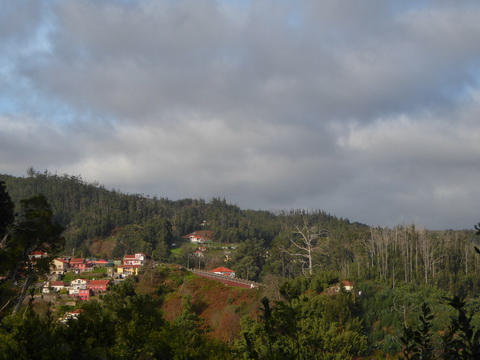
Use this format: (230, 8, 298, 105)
(12, 1, 480, 123)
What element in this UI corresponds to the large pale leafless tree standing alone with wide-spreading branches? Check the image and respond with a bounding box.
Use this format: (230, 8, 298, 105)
(281, 219, 327, 276)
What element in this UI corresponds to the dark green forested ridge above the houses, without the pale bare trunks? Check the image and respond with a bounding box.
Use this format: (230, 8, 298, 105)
(0, 169, 360, 275)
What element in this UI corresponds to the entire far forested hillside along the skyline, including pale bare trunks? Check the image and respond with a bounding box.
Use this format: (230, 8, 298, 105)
(0, 169, 480, 293)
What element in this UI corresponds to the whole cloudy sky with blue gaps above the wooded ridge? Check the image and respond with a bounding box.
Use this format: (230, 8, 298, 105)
(0, 0, 480, 229)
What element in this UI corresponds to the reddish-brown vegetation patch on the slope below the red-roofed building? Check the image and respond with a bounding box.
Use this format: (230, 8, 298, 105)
(163, 276, 259, 343)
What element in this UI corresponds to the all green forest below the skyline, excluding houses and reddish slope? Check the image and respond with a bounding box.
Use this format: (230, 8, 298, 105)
(0, 169, 480, 359)
